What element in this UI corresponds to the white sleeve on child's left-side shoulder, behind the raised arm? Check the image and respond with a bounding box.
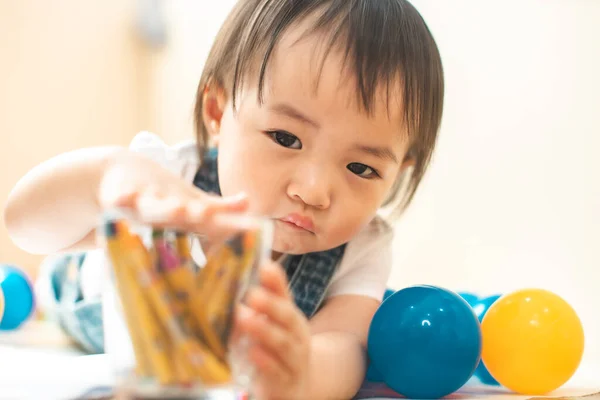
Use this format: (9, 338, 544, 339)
(129, 132, 200, 182)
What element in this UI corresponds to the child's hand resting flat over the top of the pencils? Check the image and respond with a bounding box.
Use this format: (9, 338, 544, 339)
(98, 153, 248, 236)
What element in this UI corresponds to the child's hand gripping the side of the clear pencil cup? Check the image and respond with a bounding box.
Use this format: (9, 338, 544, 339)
(236, 264, 311, 400)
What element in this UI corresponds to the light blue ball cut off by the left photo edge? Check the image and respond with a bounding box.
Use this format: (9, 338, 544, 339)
(0, 265, 35, 331)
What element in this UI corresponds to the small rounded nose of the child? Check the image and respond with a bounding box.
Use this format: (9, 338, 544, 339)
(287, 165, 331, 210)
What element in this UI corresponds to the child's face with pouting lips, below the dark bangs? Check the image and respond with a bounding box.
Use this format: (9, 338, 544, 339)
(211, 26, 408, 254)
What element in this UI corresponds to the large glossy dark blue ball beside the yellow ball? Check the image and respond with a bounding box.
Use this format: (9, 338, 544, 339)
(368, 286, 481, 399)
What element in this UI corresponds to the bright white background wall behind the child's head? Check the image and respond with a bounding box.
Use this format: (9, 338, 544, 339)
(146, 0, 600, 358)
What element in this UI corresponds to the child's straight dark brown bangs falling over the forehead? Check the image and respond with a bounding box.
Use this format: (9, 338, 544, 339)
(230, 0, 443, 136)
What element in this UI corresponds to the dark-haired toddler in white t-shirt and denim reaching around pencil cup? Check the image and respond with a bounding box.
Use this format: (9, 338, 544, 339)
(5, 0, 444, 399)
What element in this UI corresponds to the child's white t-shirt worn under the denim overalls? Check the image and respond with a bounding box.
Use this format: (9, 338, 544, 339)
(75, 132, 393, 300)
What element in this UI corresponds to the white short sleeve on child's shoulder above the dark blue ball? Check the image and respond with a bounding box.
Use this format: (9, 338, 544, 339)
(326, 218, 394, 300)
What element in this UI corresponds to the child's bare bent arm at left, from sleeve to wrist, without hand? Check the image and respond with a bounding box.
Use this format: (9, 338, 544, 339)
(4, 147, 123, 254)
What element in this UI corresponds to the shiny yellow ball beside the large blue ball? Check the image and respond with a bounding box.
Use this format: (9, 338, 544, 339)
(481, 289, 584, 395)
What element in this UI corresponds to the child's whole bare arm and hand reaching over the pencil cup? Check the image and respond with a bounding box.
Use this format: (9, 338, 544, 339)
(4, 147, 247, 254)
